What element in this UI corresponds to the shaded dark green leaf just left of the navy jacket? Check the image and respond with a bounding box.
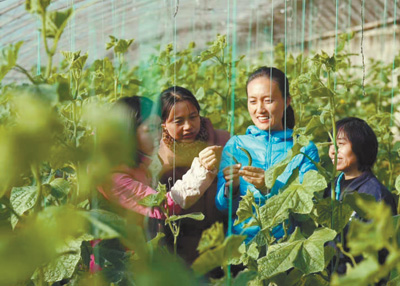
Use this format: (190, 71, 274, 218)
(310, 198, 353, 232)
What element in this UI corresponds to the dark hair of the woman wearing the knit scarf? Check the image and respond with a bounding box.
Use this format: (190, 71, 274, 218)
(161, 86, 200, 122)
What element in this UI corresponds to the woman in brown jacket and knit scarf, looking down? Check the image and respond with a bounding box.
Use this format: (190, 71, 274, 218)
(158, 86, 229, 264)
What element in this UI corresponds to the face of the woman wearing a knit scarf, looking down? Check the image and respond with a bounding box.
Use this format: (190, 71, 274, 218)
(163, 100, 200, 143)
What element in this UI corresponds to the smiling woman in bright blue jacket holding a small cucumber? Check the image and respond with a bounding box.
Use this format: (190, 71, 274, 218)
(215, 67, 319, 242)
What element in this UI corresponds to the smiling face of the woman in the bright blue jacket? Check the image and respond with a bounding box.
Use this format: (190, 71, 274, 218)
(247, 76, 290, 131)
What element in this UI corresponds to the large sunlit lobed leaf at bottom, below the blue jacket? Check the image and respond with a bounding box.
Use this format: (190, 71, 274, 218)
(258, 228, 336, 279)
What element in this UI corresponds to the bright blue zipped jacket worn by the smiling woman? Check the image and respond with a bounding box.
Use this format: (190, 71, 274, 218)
(215, 125, 319, 242)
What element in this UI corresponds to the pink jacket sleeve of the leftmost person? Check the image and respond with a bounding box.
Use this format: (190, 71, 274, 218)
(110, 173, 180, 219)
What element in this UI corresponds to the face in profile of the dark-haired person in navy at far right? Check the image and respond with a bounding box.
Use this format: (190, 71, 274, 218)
(329, 132, 362, 179)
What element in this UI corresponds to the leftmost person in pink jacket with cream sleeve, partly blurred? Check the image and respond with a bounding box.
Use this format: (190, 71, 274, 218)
(90, 96, 219, 272)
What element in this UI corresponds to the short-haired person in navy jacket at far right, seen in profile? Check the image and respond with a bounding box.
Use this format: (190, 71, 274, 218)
(324, 117, 396, 278)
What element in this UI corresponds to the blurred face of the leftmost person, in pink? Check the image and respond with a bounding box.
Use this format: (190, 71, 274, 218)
(136, 115, 161, 155)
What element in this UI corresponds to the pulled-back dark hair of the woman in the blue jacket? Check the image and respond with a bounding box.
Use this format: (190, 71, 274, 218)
(246, 67, 295, 129)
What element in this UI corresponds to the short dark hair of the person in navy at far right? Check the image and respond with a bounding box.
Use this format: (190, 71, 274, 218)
(336, 117, 378, 172)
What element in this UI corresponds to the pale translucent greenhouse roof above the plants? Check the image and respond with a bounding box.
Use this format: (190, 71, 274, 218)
(0, 0, 400, 80)
